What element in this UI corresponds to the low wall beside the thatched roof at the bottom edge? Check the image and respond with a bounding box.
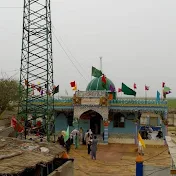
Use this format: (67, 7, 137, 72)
(48, 161, 74, 176)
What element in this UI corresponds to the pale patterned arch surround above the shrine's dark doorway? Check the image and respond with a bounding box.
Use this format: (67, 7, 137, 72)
(74, 106, 109, 120)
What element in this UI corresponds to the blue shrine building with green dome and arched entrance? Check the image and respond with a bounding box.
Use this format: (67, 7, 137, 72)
(55, 76, 168, 144)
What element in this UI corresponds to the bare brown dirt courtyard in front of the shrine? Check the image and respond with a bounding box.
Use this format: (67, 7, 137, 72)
(69, 144, 171, 176)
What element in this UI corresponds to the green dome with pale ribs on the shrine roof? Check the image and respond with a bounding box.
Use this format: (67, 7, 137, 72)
(86, 77, 116, 92)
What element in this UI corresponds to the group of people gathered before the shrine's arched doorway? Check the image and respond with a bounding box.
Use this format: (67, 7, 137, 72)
(58, 128, 98, 160)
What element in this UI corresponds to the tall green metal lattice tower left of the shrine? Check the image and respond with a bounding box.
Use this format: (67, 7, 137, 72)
(18, 0, 54, 140)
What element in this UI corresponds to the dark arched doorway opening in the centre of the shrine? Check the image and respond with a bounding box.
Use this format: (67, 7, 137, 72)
(80, 110, 103, 134)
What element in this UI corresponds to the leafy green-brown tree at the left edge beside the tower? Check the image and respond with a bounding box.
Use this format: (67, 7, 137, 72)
(0, 78, 19, 114)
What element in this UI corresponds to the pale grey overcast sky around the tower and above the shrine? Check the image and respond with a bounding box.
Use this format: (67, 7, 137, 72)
(0, 0, 176, 97)
